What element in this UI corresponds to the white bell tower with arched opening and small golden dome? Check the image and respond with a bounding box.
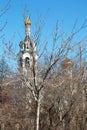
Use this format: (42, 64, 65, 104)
(19, 18, 37, 74)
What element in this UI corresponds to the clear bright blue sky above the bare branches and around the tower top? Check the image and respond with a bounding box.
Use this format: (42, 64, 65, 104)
(0, 0, 87, 68)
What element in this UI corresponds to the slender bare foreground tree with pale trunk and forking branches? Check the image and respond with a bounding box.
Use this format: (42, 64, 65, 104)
(15, 18, 87, 130)
